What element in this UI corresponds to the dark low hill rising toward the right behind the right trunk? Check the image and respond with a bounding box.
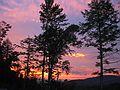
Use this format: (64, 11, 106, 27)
(64, 76, 120, 90)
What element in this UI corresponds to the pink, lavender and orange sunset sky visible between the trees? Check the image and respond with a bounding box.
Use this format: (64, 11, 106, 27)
(0, 0, 119, 79)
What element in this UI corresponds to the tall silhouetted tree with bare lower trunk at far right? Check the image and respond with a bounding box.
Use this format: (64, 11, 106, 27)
(80, 0, 120, 90)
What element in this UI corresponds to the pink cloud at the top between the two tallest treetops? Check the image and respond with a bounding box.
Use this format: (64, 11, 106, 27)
(55, 0, 91, 15)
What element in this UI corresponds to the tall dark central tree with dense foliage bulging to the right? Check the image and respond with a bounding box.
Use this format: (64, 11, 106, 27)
(38, 0, 78, 89)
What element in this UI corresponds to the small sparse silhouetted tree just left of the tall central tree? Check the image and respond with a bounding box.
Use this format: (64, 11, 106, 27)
(15, 37, 37, 78)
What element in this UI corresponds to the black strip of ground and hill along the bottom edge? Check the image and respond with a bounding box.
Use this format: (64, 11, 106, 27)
(0, 76, 120, 90)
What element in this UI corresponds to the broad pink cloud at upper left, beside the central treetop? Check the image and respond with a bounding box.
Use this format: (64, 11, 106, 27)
(0, 0, 39, 22)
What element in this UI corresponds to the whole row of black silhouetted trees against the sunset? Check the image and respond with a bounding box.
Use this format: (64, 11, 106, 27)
(0, 0, 120, 90)
